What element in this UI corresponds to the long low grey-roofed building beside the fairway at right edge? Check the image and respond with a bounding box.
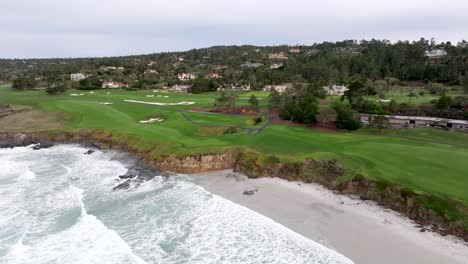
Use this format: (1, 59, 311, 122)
(357, 114, 468, 131)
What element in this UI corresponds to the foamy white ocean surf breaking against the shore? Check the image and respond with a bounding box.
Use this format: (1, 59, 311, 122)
(0, 145, 352, 264)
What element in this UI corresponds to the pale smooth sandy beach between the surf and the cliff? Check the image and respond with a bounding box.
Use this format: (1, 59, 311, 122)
(192, 171, 468, 264)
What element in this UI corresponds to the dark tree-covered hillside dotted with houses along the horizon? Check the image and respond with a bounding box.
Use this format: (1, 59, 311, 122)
(0, 39, 468, 92)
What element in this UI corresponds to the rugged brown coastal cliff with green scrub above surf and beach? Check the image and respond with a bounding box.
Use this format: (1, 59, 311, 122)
(0, 130, 468, 241)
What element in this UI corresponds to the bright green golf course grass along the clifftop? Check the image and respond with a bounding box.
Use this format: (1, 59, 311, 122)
(0, 87, 468, 203)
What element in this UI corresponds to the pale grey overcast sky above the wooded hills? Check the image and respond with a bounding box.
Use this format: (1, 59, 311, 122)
(0, 0, 468, 58)
